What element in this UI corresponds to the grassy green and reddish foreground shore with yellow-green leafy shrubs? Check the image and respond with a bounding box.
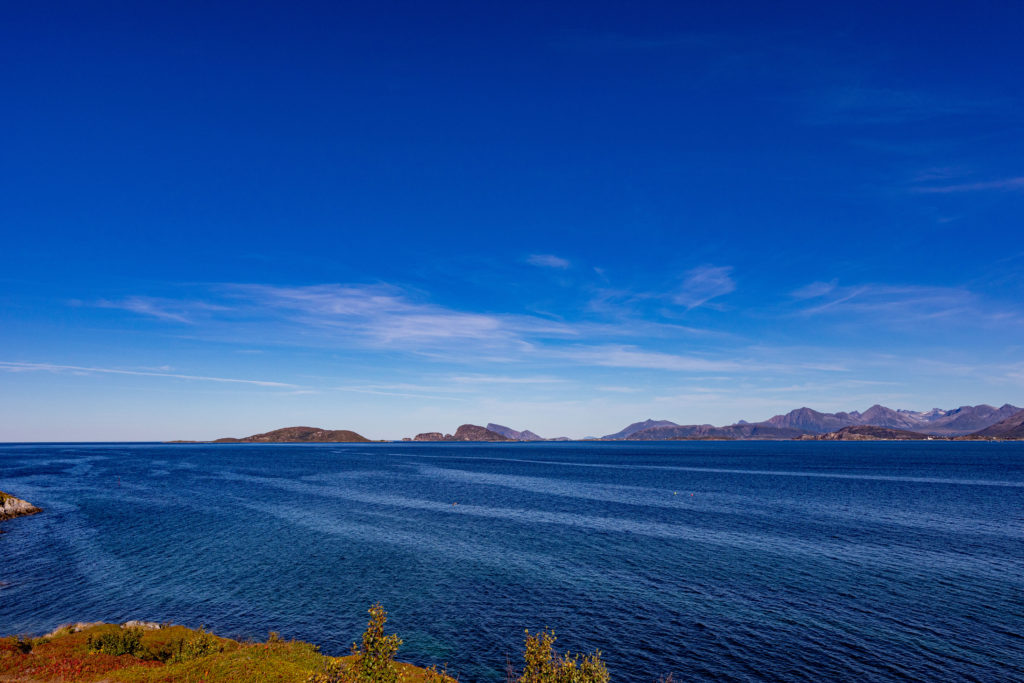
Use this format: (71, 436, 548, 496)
(0, 604, 608, 683)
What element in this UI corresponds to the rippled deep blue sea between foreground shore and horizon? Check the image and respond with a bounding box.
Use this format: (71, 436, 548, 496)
(0, 442, 1024, 682)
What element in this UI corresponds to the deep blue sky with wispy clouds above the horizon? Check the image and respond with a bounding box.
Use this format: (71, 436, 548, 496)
(0, 2, 1024, 440)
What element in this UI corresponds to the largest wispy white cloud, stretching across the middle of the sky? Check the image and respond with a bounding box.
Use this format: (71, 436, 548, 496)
(86, 276, 731, 364)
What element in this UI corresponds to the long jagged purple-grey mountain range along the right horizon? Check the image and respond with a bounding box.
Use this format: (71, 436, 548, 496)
(601, 403, 1021, 441)
